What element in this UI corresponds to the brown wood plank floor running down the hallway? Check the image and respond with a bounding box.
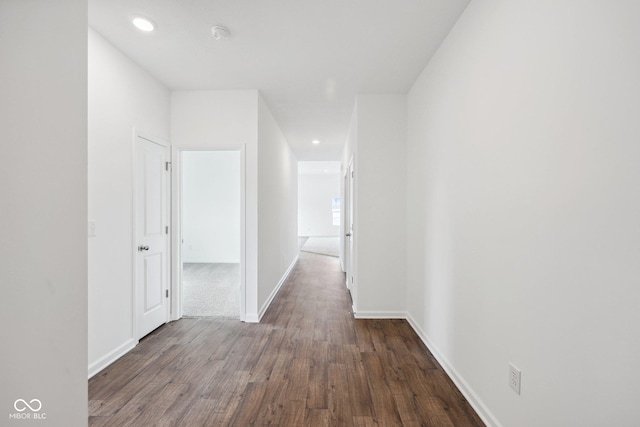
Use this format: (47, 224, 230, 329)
(89, 253, 484, 427)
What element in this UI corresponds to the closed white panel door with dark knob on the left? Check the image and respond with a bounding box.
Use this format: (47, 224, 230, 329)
(135, 136, 169, 339)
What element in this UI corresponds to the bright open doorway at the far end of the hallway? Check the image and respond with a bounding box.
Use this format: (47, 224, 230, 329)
(298, 161, 342, 258)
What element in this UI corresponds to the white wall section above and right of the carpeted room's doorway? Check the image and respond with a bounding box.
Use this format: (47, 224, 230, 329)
(171, 90, 258, 321)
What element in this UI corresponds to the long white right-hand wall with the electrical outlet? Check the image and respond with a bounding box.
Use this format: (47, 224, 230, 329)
(407, 0, 640, 427)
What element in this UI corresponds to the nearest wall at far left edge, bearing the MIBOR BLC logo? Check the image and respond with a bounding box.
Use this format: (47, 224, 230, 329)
(0, 0, 87, 427)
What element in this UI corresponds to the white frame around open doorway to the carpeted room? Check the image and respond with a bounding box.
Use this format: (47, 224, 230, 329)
(170, 144, 247, 322)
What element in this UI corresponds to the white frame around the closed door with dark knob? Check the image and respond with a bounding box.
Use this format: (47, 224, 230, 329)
(131, 128, 173, 342)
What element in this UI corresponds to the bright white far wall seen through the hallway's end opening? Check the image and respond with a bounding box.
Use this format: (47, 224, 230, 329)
(298, 162, 342, 236)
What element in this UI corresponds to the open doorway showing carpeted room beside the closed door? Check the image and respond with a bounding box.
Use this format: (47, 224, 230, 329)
(180, 151, 242, 319)
